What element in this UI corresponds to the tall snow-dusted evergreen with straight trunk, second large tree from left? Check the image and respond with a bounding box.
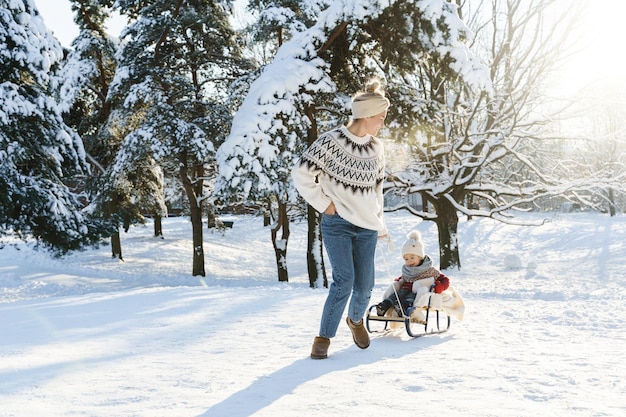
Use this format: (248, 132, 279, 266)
(111, 0, 249, 276)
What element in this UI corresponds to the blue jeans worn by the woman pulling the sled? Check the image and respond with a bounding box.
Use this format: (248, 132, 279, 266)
(319, 214, 378, 338)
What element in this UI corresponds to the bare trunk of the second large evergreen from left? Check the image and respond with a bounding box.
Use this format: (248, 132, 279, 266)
(180, 162, 206, 277)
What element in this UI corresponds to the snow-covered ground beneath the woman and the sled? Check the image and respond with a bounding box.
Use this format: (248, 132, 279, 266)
(0, 213, 626, 417)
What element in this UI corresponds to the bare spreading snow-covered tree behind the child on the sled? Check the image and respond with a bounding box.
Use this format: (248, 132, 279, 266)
(382, 0, 589, 269)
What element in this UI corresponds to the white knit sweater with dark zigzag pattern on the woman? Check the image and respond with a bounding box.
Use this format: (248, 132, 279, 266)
(292, 127, 387, 236)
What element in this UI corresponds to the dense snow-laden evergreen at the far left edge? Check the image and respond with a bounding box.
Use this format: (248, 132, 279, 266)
(0, 0, 111, 253)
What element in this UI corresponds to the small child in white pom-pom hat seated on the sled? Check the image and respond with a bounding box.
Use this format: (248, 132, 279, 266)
(376, 230, 450, 317)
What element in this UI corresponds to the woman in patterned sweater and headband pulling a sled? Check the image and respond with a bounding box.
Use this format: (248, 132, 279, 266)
(292, 80, 389, 359)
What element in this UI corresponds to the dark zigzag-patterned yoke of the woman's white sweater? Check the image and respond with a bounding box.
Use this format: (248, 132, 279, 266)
(301, 129, 384, 191)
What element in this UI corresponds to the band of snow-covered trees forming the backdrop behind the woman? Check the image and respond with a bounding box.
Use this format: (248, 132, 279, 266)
(0, 0, 626, 286)
